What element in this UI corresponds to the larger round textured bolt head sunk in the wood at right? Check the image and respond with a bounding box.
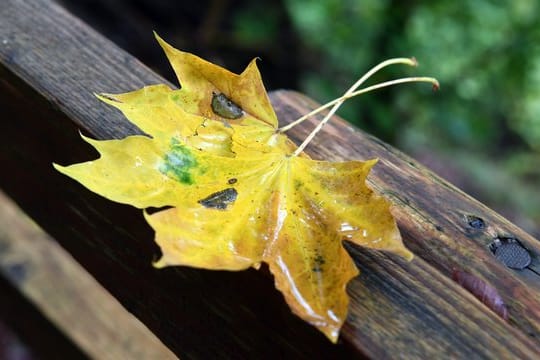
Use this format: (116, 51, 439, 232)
(489, 236, 531, 270)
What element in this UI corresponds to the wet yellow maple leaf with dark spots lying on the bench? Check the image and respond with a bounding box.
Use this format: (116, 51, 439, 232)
(54, 38, 438, 342)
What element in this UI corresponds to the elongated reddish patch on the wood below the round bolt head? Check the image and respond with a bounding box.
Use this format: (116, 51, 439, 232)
(452, 269, 508, 320)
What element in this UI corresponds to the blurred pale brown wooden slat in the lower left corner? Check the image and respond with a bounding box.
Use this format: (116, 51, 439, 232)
(0, 192, 176, 359)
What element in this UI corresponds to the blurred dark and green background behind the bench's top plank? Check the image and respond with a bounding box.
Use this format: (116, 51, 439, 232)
(60, 0, 540, 237)
